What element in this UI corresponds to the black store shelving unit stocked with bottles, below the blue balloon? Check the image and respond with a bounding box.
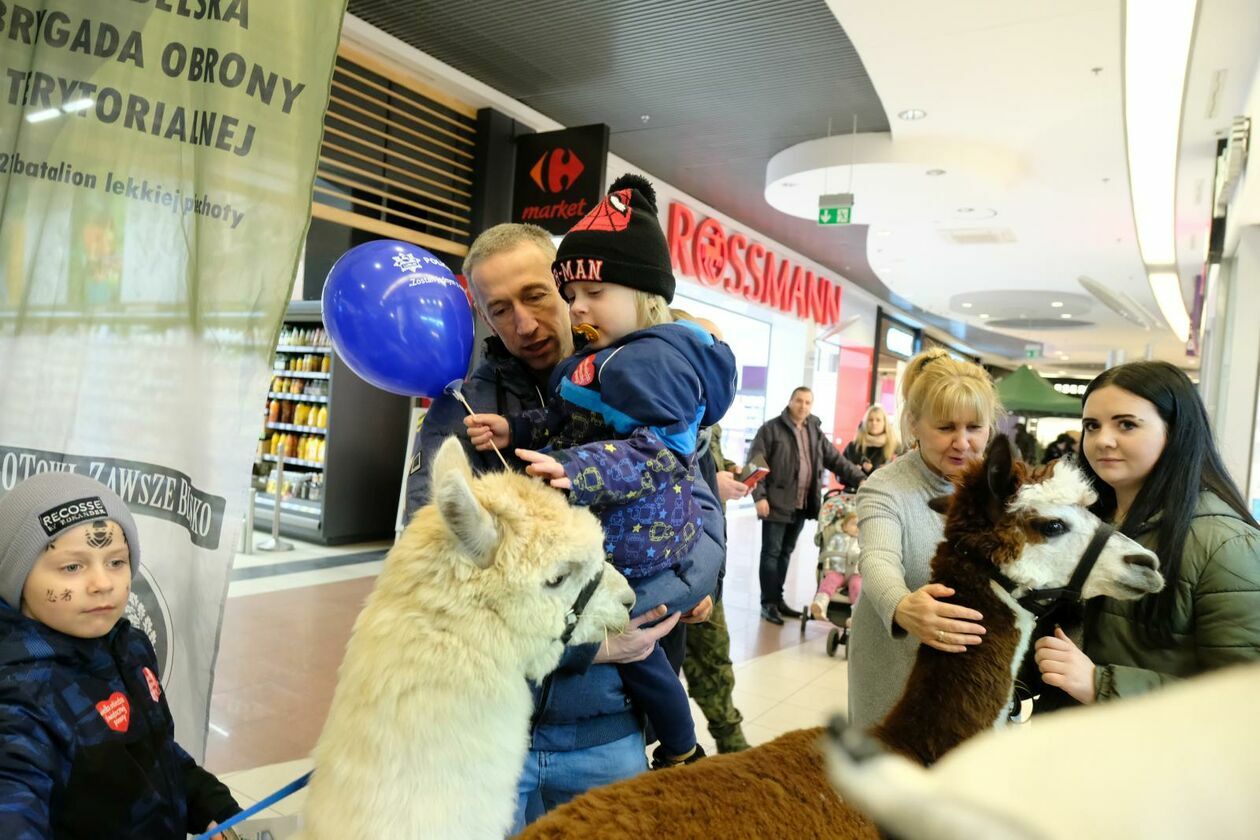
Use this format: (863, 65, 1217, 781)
(253, 301, 410, 545)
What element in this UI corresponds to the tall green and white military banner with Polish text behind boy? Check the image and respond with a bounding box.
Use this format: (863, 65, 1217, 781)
(0, 0, 345, 757)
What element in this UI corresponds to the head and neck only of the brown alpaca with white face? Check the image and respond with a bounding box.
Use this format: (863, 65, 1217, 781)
(872, 437, 1163, 764)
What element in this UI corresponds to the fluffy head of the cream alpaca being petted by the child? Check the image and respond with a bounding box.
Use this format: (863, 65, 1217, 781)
(408, 437, 634, 680)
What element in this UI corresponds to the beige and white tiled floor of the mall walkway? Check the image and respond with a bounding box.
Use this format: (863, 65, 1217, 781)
(205, 510, 848, 815)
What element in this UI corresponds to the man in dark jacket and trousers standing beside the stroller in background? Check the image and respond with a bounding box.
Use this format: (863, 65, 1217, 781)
(748, 385, 866, 625)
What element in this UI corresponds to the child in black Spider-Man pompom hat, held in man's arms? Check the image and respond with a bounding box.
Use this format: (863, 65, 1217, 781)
(465, 175, 736, 767)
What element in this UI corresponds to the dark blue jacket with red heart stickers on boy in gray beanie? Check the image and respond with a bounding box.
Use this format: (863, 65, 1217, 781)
(0, 601, 241, 840)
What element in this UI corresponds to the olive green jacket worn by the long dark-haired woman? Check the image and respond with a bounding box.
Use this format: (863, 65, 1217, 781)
(1084, 491, 1260, 700)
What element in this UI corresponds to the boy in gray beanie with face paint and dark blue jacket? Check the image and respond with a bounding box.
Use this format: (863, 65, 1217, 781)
(0, 472, 241, 840)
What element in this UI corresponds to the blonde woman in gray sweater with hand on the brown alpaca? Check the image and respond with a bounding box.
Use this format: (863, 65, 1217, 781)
(849, 349, 1002, 728)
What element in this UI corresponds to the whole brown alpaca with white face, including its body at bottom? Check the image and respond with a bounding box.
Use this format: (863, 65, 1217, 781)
(520, 436, 1163, 840)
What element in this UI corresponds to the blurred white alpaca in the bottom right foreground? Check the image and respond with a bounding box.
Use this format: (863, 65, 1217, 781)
(827, 665, 1260, 840)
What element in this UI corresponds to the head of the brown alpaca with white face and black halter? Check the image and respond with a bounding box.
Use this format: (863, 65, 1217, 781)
(945, 436, 1164, 601)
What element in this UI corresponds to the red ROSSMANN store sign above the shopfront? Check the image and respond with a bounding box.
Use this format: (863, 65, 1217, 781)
(668, 201, 844, 326)
